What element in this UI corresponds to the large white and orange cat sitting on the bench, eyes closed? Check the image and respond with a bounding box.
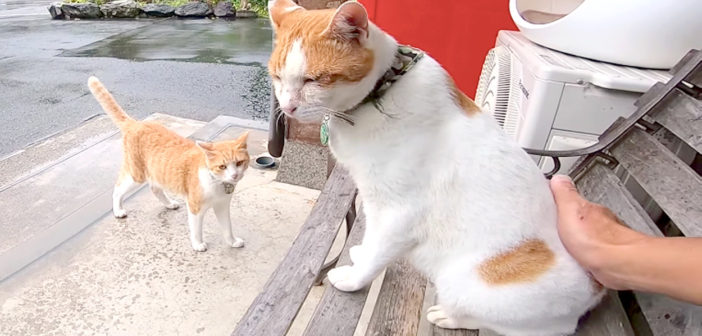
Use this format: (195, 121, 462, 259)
(269, 0, 604, 336)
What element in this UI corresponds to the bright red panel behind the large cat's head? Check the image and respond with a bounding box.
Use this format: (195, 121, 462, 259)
(360, 0, 516, 97)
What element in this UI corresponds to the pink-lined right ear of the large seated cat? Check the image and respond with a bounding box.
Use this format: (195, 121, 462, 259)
(326, 1, 368, 45)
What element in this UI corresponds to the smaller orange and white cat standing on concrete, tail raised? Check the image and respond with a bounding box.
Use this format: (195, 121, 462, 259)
(88, 77, 249, 252)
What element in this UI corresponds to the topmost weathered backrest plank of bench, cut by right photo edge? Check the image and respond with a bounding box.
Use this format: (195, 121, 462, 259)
(649, 89, 702, 153)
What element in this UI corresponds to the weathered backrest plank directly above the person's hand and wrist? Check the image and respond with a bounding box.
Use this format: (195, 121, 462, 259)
(576, 164, 663, 237)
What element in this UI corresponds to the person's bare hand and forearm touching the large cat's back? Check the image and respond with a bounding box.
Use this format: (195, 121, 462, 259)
(551, 176, 702, 305)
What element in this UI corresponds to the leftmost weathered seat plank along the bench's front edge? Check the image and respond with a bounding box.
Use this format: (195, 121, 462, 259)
(232, 166, 356, 336)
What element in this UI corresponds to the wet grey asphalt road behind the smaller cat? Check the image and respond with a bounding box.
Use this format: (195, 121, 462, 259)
(0, 0, 272, 158)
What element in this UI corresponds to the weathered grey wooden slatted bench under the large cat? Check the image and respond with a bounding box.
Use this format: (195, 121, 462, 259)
(233, 52, 702, 336)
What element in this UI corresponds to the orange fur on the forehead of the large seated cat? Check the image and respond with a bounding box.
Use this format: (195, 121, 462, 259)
(268, 1, 374, 86)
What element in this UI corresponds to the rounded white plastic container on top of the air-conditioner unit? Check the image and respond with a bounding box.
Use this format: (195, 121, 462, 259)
(509, 0, 702, 69)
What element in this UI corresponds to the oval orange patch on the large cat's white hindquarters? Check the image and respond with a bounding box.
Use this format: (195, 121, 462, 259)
(478, 239, 555, 285)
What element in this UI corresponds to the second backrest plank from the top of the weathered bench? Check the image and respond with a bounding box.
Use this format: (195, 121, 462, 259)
(611, 129, 702, 237)
